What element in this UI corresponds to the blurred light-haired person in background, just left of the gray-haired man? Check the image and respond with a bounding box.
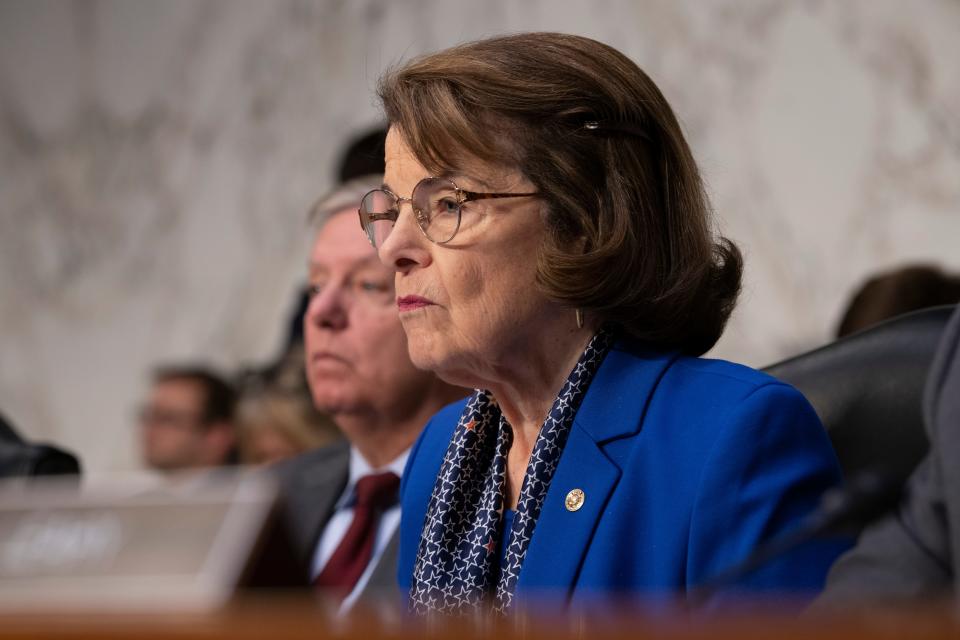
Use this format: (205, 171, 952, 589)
(237, 386, 342, 464)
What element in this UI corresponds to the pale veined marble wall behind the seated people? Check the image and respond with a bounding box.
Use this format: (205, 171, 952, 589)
(0, 0, 960, 471)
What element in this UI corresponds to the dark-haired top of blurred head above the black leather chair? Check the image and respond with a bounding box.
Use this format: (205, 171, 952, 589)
(837, 265, 960, 338)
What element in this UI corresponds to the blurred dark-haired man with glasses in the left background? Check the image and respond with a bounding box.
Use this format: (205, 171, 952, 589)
(138, 366, 237, 473)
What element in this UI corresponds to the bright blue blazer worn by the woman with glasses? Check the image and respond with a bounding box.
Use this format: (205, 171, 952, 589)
(398, 342, 849, 604)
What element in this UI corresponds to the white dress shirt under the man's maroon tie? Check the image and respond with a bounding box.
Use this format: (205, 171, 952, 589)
(310, 446, 410, 614)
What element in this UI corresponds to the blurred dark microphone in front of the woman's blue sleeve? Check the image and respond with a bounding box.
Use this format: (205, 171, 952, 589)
(687, 471, 903, 606)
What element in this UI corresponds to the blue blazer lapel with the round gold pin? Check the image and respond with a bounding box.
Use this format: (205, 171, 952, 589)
(517, 343, 679, 605)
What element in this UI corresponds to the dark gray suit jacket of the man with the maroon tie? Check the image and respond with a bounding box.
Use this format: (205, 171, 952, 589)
(272, 441, 399, 600)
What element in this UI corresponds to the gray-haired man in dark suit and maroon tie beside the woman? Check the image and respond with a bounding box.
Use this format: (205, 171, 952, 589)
(275, 176, 466, 612)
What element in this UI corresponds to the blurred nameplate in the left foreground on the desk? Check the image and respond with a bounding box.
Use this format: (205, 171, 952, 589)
(0, 473, 301, 613)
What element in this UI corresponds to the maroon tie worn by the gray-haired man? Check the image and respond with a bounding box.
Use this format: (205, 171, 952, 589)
(313, 471, 400, 600)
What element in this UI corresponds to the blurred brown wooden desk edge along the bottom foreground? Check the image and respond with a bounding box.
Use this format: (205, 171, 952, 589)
(0, 598, 960, 640)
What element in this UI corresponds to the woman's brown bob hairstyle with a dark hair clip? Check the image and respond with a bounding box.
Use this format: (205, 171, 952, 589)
(379, 33, 743, 355)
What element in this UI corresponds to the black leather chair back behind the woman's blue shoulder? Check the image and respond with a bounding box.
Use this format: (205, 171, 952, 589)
(764, 305, 954, 482)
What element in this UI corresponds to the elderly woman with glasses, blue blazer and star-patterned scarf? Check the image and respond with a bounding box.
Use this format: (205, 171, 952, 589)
(360, 33, 841, 613)
